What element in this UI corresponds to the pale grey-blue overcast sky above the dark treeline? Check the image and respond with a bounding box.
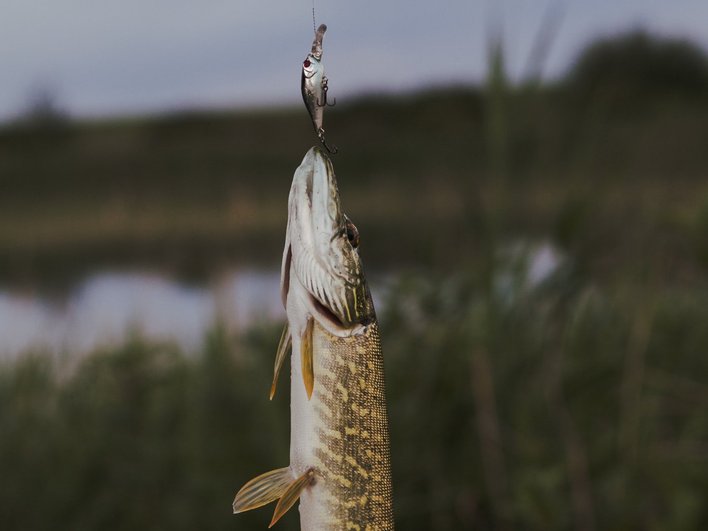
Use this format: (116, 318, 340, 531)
(0, 0, 708, 120)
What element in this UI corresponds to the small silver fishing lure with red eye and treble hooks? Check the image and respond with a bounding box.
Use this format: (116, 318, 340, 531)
(300, 24, 337, 154)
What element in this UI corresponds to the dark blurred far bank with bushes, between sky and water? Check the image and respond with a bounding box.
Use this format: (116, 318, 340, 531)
(0, 31, 708, 285)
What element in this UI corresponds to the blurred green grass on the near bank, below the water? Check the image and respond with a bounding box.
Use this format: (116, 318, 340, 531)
(0, 269, 708, 530)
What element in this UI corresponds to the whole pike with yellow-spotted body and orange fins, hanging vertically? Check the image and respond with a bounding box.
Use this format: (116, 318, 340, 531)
(233, 146, 394, 531)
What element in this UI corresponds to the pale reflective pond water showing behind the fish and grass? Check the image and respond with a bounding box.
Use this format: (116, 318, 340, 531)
(0, 242, 563, 359)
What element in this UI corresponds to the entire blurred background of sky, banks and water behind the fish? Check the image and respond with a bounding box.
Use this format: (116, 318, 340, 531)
(0, 0, 708, 531)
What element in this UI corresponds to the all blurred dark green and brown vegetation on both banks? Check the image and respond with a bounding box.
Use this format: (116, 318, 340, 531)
(0, 30, 708, 531)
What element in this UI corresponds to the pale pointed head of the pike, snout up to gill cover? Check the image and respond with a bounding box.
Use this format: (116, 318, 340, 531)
(281, 147, 375, 335)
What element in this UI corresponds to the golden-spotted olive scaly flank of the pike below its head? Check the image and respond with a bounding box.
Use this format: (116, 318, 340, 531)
(312, 323, 393, 531)
